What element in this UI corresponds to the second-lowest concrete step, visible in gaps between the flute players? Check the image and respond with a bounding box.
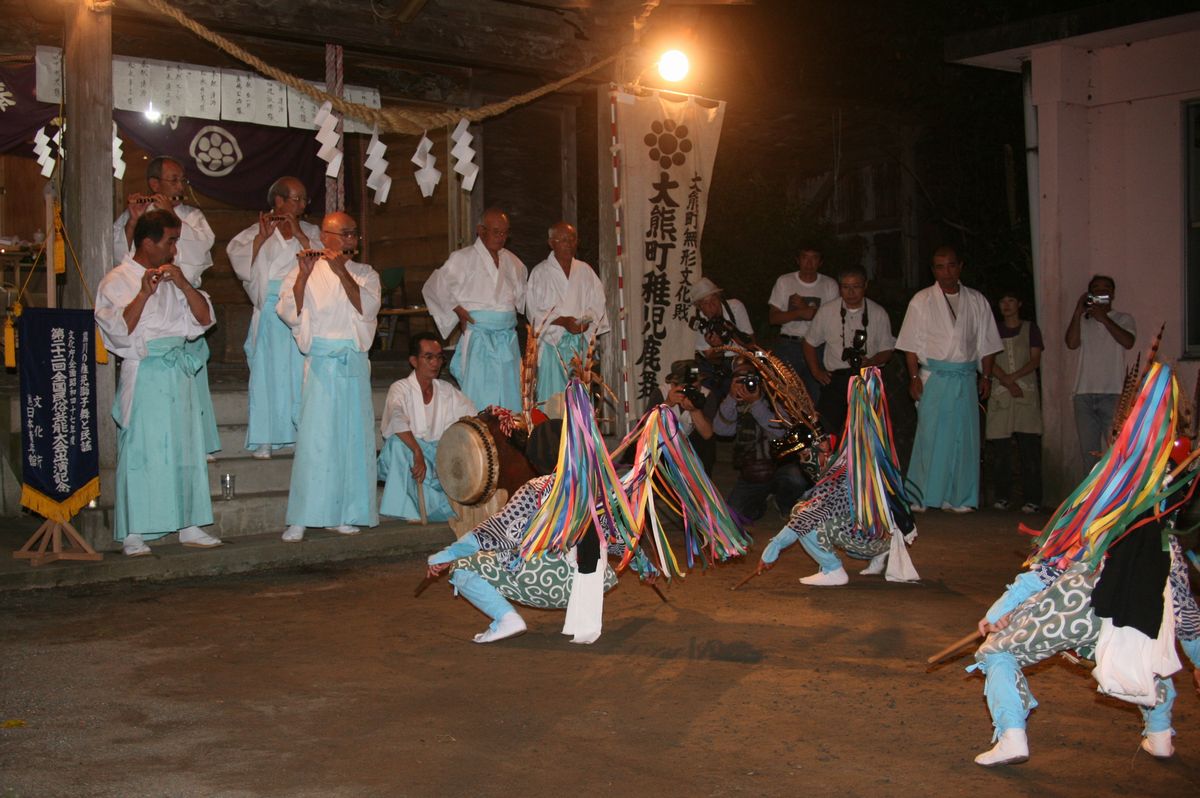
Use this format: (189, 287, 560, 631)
(73, 482, 408, 551)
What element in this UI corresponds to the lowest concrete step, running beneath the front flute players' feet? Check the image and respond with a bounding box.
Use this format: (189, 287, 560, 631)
(0, 520, 455, 590)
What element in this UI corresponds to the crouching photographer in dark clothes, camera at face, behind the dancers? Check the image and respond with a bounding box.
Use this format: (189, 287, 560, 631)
(713, 360, 812, 521)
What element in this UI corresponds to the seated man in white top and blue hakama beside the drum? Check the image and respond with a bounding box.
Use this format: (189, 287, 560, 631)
(379, 332, 475, 521)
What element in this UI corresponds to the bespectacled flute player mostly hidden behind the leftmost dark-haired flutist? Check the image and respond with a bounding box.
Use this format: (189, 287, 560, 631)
(113, 155, 221, 462)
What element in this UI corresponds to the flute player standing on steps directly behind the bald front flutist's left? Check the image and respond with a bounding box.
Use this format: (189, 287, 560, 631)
(226, 176, 320, 460)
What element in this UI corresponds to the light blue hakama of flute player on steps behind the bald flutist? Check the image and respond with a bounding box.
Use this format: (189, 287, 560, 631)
(245, 280, 304, 449)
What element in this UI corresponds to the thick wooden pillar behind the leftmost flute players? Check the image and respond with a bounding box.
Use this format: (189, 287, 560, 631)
(62, 2, 116, 470)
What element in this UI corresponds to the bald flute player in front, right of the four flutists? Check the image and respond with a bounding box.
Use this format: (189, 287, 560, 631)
(275, 212, 379, 542)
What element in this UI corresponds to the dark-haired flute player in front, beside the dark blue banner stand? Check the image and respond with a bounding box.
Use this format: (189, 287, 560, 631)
(96, 210, 221, 557)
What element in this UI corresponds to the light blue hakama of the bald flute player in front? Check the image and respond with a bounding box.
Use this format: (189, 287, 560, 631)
(287, 338, 379, 527)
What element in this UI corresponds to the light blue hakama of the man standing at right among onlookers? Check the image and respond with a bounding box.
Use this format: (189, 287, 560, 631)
(907, 360, 979, 509)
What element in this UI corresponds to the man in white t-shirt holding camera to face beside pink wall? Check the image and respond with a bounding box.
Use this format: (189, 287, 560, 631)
(1067, 275, 1138, 472)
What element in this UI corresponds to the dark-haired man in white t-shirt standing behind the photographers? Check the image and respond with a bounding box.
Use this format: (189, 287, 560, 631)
(767, 244, 838, 402)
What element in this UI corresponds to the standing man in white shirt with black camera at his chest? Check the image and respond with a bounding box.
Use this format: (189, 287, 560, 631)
(804, 266, 896, 437)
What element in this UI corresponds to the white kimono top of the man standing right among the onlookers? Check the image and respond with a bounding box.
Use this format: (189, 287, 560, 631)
(896, 283, 1004, 379)
